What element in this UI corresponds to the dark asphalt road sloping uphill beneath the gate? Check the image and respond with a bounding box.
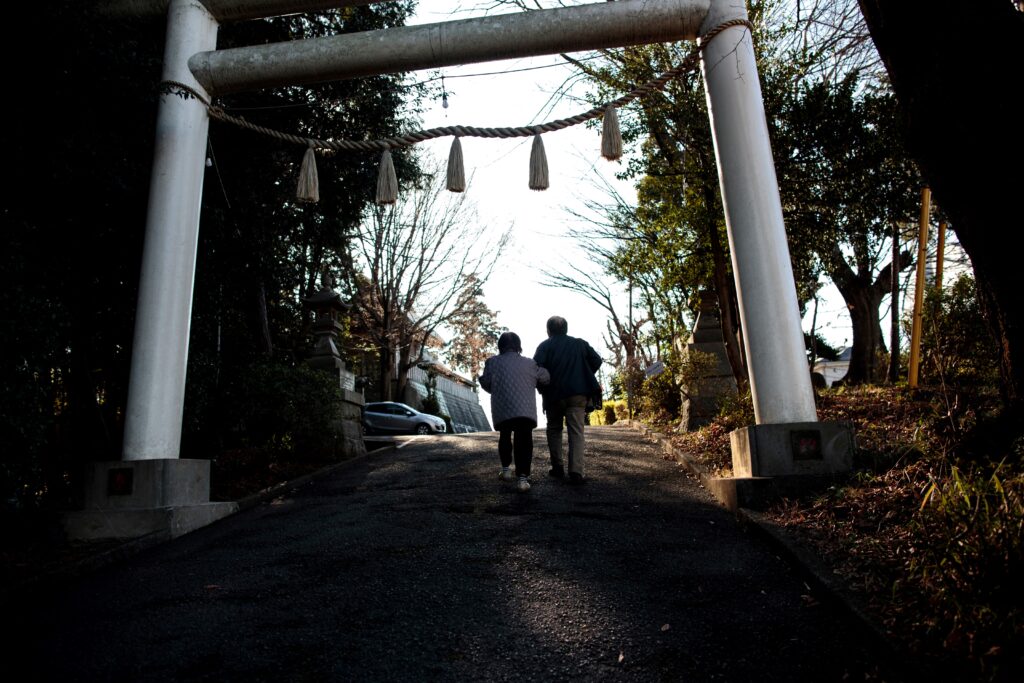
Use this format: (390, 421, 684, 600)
(3, 427, 899, 682)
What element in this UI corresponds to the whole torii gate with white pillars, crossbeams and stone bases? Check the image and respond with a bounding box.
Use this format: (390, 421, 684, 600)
(70, 0, 852, 532)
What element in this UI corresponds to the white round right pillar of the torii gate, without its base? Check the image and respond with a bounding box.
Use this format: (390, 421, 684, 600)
(700, 1, 817, 424)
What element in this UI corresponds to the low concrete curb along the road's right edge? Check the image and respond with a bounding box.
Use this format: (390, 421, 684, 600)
(615, 420, 929, 681)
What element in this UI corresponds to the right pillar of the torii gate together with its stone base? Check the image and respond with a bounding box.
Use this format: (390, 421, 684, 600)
(700, 0, 853, 491)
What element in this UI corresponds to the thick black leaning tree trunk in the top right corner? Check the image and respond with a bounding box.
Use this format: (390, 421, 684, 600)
(860, 0, 1024, 414)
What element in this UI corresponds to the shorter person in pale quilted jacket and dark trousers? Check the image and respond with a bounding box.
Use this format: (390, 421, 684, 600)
(479, 332, 551, 494)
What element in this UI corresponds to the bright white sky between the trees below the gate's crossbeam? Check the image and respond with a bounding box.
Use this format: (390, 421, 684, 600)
(413, 78, 633, 360)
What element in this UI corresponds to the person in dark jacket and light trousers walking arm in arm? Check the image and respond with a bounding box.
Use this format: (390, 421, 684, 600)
(534, 315, 601, 483)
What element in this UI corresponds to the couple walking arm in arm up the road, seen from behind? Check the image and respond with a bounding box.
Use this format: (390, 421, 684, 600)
(479, 315, 601, 493)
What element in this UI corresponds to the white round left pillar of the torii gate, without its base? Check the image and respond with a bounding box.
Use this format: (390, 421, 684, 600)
(123, 0, 218, 461)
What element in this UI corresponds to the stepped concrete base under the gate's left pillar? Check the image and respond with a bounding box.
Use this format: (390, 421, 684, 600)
(63, 459, 239, 541)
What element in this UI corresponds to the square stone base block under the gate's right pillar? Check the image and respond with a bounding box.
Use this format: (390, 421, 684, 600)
(729, 422, 854, 478)
